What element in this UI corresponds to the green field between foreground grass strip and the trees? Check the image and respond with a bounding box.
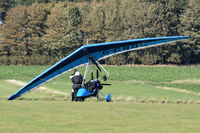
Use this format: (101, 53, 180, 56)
(0, 66, 200, 103)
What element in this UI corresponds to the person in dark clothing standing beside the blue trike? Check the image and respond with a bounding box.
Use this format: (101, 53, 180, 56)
(70, 69, 83, 101)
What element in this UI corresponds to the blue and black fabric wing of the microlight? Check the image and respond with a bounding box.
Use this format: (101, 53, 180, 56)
(8, 36, 189, 100)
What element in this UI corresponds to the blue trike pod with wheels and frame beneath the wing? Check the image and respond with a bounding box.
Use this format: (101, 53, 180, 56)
(76, 57, 112, 102)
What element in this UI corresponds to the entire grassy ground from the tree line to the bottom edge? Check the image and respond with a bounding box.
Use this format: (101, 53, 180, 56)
(0, 66, 200, 133)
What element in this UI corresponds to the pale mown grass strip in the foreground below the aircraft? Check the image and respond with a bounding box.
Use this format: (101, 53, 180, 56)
(0, 101, 200, 133)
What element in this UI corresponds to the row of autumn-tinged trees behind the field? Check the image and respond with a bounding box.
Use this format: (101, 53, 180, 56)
(0, 0, 200, 65)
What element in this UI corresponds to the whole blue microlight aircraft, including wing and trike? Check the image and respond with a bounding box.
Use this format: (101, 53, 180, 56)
(8, 36, 189, 102)
